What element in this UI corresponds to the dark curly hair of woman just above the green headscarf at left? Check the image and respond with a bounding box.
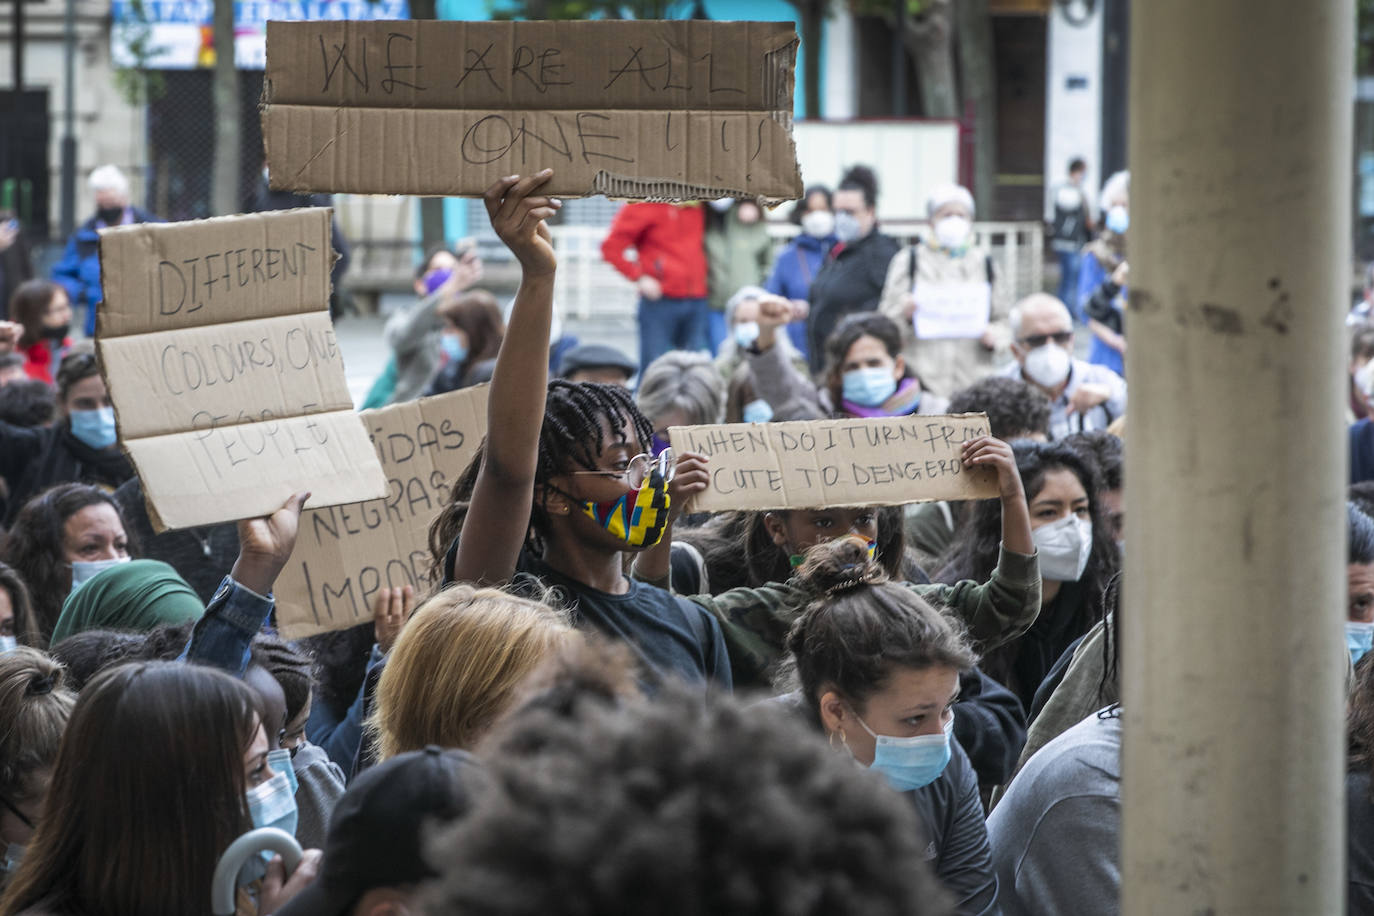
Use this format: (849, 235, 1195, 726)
(0, 483, 137, 648)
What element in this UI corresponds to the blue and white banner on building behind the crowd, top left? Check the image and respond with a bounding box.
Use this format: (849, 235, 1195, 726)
(110, 0, 411, 70)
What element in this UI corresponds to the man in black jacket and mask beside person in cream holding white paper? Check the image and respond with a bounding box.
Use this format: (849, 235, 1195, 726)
(807, 165, 899, 372)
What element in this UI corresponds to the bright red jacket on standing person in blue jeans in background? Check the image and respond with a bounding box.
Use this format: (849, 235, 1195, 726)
(602, 203, 706, 299)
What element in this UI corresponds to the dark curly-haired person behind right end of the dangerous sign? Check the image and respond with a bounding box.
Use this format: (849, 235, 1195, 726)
(905, 375, 1050, 569)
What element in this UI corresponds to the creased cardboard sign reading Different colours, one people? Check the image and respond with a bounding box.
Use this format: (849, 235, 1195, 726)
(96, 209, 386, 531)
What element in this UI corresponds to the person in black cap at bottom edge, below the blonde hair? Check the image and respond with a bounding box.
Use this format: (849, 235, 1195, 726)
(276, 746, 486, 916)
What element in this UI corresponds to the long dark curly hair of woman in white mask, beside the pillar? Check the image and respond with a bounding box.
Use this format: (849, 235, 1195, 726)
(934, 441, 1121, 696)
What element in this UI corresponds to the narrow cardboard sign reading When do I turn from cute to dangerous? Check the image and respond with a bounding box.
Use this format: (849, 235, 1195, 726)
(668, 413, 998, 512)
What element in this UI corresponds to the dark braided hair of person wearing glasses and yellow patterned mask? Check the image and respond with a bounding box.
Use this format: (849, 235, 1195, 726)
(429, 379, 654, 581)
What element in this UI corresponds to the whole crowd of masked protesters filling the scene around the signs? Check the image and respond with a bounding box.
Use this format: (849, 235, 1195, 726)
(0, 157, 1374, 916)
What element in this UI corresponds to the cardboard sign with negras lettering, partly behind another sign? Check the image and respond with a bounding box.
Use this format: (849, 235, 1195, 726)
(275, 385, 486, 639)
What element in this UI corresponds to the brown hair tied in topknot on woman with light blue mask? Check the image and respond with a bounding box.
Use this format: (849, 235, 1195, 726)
(783, 537, 978, 724)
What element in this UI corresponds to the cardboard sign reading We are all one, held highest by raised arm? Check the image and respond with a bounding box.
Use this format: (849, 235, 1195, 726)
(262, 21, 801, 202)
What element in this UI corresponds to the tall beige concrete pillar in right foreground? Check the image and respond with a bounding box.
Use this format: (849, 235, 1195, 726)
(1121, 0, 1355, 916)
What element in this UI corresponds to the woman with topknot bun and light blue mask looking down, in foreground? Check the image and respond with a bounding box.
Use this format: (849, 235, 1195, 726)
(785, 537, 999, 913)
